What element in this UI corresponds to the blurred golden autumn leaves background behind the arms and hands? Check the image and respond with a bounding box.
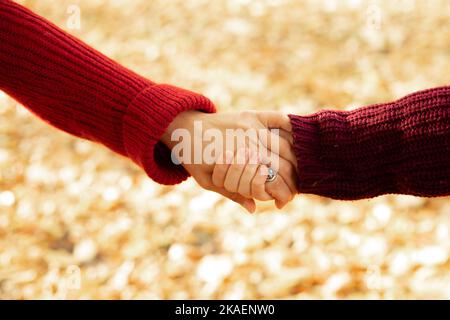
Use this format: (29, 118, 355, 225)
(0, 0, 450, 299)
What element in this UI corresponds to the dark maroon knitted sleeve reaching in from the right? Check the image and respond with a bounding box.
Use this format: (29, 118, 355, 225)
(290, 87, 450, 200)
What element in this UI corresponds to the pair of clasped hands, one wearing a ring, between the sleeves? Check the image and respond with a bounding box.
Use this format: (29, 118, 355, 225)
(162, 111, 297, 213)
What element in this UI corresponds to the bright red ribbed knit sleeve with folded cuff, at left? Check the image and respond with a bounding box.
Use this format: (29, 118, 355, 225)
(0, 0, 215, 184)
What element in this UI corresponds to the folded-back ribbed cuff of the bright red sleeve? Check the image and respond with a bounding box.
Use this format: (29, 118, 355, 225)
(122, 84, 216, 185)
